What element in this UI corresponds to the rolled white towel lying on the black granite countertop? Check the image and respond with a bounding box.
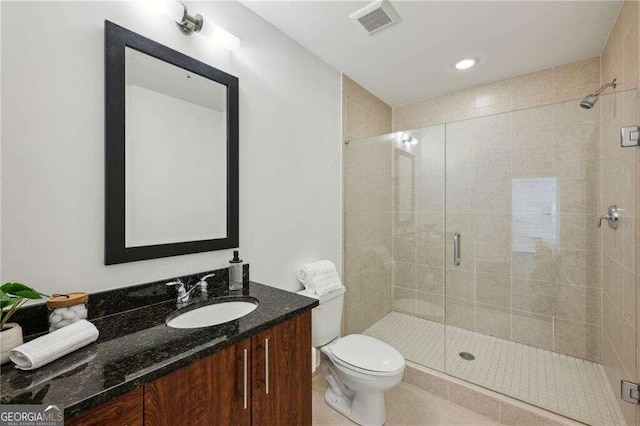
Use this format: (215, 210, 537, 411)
(9, 320, 99, 370)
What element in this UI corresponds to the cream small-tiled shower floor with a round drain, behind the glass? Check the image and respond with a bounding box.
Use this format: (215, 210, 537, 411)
(364, 312, 625, 425)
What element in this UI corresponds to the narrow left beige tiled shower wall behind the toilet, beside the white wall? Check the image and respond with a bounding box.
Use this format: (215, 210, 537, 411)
(342, 75, 392, 333)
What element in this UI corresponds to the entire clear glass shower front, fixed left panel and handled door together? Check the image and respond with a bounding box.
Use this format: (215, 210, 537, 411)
(344, 90, 640, 424)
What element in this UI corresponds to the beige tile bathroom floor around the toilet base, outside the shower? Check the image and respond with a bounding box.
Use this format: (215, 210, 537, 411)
(313, 374, 499, 426)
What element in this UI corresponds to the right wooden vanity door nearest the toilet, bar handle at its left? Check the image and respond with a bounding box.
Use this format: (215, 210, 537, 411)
(251, 311, 312, 426)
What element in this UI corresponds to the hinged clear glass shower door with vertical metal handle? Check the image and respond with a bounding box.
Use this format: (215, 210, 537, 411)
(445, 95, 636, 424)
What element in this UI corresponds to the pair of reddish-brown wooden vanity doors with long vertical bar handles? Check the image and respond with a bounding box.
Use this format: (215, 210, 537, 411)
(144, 311, 312, 426)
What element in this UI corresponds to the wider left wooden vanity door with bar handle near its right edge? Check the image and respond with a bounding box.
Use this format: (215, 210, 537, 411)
(144, 339, 251, 426)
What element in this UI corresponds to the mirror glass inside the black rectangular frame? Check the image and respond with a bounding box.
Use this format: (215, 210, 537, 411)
(125, 47, 228, 247)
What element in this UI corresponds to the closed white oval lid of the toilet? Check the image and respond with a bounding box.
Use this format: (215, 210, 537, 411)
(331, 334, 404, 372)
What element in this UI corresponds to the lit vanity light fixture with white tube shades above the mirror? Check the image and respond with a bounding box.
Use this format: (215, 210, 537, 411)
(149, 0, 240, 50)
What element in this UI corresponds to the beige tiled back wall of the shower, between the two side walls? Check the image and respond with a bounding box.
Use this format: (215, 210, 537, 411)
(392, 57, 602, 361)
